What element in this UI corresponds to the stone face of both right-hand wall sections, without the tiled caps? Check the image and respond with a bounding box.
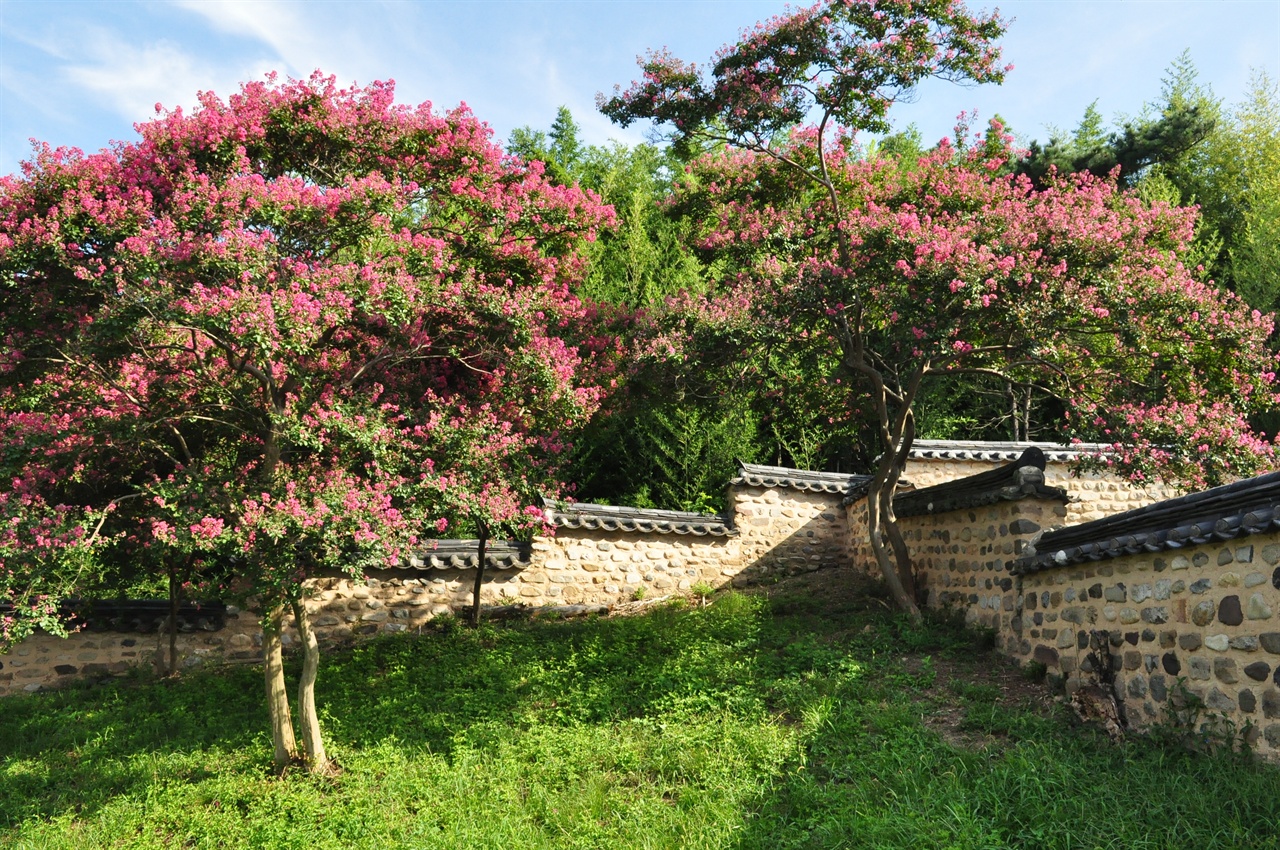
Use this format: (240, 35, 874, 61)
(870, 491, 1280, 760)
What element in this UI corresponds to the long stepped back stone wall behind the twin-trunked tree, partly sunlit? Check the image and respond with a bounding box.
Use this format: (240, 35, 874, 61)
(0, 474, 847, 695)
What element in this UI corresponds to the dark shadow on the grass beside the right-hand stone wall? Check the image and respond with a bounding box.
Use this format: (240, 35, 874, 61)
(732, 645, 1280, 850)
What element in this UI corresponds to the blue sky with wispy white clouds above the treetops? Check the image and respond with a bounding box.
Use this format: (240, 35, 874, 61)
(0, 0, 1280, 174)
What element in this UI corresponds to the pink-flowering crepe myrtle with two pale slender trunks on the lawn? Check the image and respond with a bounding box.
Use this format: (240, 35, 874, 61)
(0, 73, 612, 771)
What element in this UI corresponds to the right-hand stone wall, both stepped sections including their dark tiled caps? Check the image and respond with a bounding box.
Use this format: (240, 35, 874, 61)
(850, 455, 1280, 760)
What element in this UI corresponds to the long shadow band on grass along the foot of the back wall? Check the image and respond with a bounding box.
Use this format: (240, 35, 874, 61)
(0, 583, 906, 828)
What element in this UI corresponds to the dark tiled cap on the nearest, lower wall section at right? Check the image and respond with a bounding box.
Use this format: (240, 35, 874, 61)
(1011, 472, 1280, 573)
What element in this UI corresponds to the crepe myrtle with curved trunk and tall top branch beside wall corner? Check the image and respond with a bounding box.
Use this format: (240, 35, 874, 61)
(600, 0, 1276, 617)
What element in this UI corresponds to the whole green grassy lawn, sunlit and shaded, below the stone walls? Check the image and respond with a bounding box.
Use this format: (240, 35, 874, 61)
(0, 573, 1280, 850)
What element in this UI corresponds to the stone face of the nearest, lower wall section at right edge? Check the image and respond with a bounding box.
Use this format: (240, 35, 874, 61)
(1005, 534, 1280, 758)
